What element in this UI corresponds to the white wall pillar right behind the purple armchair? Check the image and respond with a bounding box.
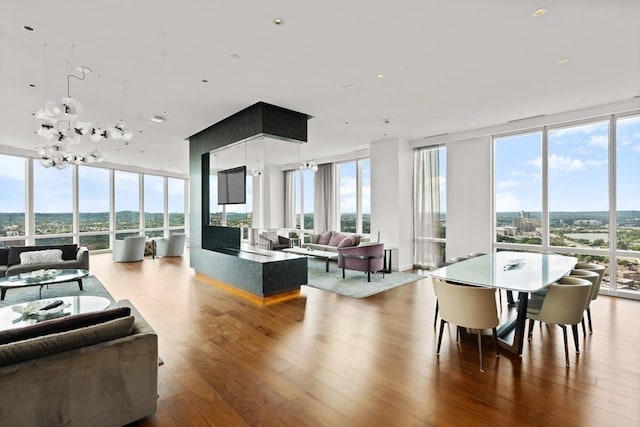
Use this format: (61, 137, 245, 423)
(370, 139, 413, 270)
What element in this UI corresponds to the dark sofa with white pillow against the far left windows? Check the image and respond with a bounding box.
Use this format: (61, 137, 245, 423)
(0, 244, 89, 277)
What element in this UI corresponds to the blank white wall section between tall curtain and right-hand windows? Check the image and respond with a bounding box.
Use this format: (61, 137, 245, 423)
(447, 137, 492, 258)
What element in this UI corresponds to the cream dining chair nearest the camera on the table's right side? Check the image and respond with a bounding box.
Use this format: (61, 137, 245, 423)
(527, 276, 593, 368)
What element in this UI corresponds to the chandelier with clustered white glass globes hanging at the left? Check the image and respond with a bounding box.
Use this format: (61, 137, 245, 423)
(35, 46, 133, 169)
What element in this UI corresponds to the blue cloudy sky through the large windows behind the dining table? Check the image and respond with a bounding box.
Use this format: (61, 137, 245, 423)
(495, 117, 640, 212)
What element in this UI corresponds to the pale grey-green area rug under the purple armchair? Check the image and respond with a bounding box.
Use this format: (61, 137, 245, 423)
(307, 259, 424, 298)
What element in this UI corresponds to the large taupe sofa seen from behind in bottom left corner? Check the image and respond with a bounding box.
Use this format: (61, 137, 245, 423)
(0, 300, 158, 427)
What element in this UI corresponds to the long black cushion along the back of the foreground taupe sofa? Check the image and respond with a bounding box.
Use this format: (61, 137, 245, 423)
(0, 307, 131, 345)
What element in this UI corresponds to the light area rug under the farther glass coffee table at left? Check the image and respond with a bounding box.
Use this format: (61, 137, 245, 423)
(0, 276, 114, 307)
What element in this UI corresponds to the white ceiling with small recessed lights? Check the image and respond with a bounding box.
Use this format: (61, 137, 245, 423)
(0, 0, 640, 174)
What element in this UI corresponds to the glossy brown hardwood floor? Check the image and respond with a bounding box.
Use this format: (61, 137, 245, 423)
(91, 254, 640, 427)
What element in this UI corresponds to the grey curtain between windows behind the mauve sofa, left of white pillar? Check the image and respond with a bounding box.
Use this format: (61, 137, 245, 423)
(313, 163, 338, 233)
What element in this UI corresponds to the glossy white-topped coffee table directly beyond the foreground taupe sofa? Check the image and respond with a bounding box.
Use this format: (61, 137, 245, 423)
(0, 295, 111, 331)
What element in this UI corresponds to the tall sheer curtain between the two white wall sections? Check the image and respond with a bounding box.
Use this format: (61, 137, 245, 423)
(413, 147, 444, 268)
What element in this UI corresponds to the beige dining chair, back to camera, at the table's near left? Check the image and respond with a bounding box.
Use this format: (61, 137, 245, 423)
(433, 278, 500, 372)
